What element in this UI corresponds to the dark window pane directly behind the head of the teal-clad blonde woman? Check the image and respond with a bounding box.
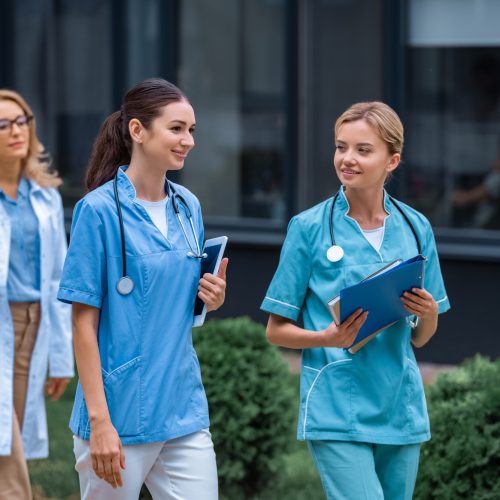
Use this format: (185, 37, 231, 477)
(298, 0, 383, 208)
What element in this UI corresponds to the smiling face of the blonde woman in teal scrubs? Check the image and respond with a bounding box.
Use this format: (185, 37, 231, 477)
(333, 119, 400, 189)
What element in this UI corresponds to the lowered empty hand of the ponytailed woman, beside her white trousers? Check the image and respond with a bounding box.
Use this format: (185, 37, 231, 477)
(90, 419, 125, 488)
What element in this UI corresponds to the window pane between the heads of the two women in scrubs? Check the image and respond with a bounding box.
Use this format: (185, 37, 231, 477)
(179, 0, 285, 222)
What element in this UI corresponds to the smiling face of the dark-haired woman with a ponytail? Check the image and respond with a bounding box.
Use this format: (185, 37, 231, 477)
(135, 100, 196, 170)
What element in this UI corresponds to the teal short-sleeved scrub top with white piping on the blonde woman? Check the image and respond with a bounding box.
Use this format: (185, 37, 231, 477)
(261, 189, 450, 445)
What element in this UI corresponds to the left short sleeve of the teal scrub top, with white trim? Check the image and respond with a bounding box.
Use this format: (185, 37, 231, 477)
(260, 217, 311, 321)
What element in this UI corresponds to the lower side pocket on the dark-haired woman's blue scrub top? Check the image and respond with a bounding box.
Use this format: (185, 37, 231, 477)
(102, 356, 143, 436)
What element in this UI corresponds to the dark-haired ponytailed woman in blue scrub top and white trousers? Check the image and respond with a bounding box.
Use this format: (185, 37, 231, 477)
(58, 79, 227, 500)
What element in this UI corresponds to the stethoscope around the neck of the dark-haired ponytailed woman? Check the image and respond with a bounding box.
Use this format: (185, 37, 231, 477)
(113, 173, 207, 295)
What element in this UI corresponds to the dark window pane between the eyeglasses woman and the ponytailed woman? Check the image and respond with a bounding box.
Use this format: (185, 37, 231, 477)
(13, 0, 113, 206)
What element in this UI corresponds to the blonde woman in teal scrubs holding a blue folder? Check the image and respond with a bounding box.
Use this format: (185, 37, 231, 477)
(262, 102, 450, 500)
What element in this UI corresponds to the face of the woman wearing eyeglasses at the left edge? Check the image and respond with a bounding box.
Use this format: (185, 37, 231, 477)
(0, 99, 30, 163)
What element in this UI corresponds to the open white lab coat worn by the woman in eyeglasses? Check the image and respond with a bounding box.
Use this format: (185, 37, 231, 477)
(0, 181, 74, 459)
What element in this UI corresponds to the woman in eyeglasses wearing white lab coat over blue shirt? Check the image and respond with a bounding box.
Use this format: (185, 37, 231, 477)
(0, 90, 73, 500)
